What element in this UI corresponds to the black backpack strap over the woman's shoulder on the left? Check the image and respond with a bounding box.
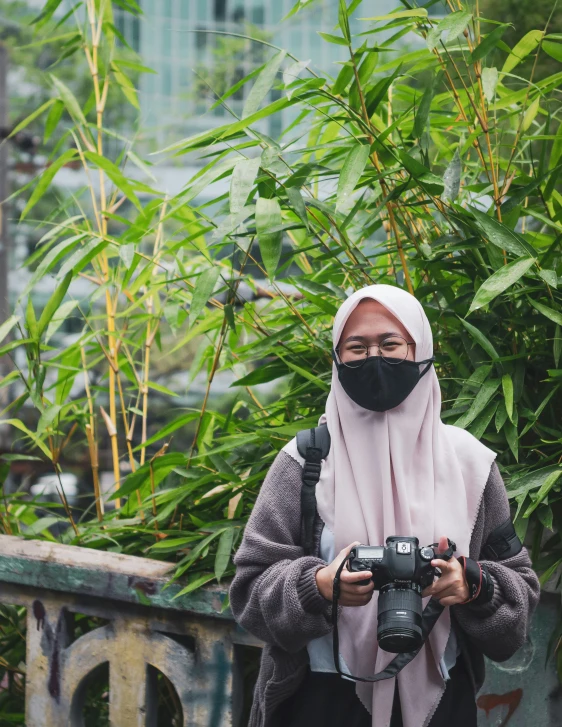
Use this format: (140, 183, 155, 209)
(297, 424, 330, 555)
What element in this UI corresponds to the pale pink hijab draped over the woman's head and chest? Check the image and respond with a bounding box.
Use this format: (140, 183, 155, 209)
(284, 285, 496, 727)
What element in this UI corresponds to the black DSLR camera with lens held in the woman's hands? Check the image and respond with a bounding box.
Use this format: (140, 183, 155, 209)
(347, 535, 450, 654)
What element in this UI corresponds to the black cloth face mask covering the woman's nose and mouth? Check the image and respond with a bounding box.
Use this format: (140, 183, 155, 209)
(332, 351, 435, 411)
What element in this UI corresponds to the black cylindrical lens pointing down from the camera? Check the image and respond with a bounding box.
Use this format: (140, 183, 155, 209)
(377, 583, 423, 654)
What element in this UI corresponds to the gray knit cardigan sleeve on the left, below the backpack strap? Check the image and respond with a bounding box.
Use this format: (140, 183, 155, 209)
(230, 451, 331, 652)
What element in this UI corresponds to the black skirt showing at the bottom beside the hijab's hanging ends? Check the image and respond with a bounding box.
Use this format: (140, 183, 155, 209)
(276, 657, 476, 727)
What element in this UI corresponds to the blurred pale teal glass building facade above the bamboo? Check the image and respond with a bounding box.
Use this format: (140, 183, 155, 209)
(116, 0, 397, 148)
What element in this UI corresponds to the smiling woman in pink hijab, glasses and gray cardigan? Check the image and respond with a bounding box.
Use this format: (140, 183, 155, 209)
(230, 285, 539, 727)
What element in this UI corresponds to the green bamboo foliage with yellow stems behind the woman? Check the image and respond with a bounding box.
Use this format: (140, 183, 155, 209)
(2, 0, 562, 700)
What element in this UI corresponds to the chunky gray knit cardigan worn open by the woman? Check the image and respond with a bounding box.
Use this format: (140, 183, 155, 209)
(230, 451, 539, 727)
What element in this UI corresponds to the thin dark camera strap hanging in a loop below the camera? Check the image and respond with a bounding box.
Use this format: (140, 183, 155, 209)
(332, 540, 456, 682)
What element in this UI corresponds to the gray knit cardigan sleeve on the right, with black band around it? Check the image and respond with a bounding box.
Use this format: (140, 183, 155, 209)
(452, 462, 540, 661)
